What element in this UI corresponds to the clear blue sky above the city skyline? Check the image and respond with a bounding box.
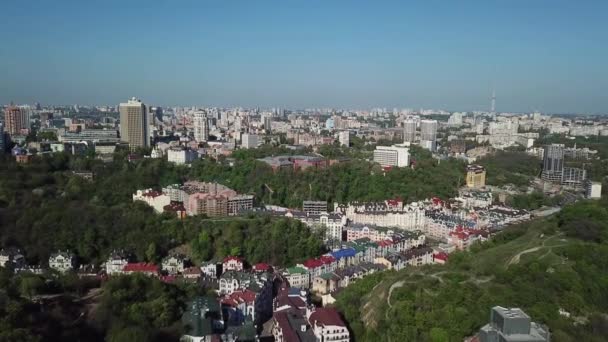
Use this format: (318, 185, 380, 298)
(0, 0, 608, 113)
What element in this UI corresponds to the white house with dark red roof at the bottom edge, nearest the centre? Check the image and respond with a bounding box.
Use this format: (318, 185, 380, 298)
(308, 308, 350, 342)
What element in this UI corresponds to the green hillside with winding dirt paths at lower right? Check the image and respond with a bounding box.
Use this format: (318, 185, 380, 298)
(337, 202, 608, 341)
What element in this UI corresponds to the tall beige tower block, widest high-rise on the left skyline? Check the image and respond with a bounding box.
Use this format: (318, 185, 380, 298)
(119, 97, 150, 149)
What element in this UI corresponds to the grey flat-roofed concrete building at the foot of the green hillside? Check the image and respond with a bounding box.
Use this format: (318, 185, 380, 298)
(477, 306, 551, 342)
